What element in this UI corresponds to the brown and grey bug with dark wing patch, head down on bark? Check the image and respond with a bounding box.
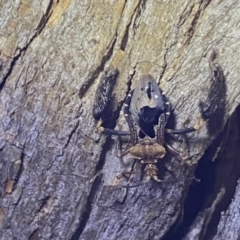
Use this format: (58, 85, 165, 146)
(94, 74, 196, 182)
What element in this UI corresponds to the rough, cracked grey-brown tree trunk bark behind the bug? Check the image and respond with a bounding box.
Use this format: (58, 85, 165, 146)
(0, 0, 240, 240)
